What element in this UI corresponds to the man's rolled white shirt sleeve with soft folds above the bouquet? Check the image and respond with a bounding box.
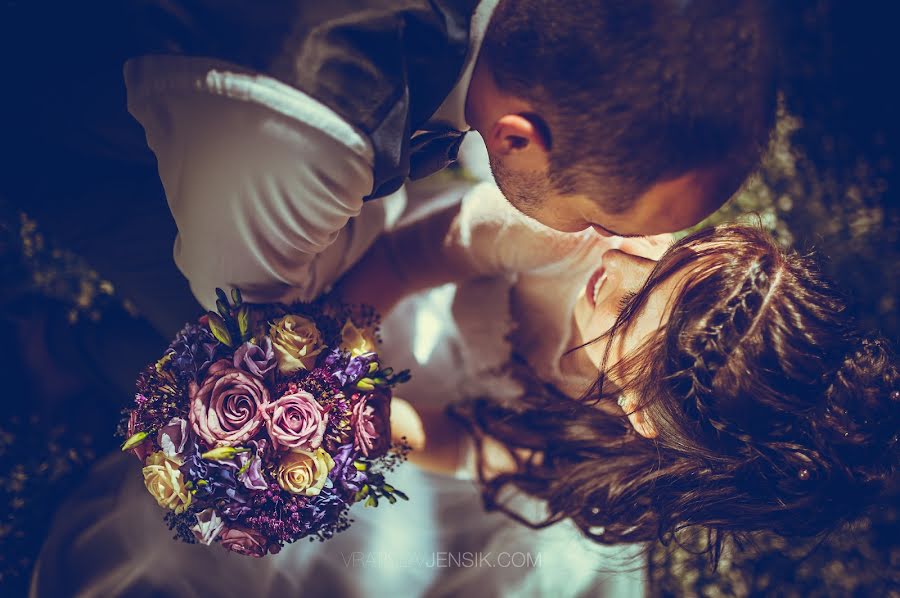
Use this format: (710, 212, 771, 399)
(125, 56, 384, 308)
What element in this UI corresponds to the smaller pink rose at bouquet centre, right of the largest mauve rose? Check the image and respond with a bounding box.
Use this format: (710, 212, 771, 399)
(265, 390, 328, 451)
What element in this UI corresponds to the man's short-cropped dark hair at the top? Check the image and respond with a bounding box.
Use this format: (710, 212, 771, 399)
(482, 0, 775, 212)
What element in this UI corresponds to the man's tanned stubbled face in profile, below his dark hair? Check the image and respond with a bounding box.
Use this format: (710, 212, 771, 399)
(490, 154, 731, 237)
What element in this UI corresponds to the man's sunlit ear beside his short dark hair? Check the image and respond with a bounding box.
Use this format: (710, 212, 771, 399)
(484, 114, 550, 170)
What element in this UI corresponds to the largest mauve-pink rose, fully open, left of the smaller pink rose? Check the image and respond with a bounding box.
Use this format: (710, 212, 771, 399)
(190, 359, 269, 446)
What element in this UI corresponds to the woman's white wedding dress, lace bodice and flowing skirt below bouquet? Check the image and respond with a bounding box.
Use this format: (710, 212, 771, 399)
(31, 146, 645, 598)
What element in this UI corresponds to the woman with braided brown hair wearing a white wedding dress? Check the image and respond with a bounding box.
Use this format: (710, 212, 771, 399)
(32, 180, 898, 596)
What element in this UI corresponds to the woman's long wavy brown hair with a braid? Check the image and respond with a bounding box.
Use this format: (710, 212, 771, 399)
(451, 225, 900, 558)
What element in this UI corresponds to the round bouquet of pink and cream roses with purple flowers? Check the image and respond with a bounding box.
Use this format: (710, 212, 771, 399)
(120, 290, 409, 557)
